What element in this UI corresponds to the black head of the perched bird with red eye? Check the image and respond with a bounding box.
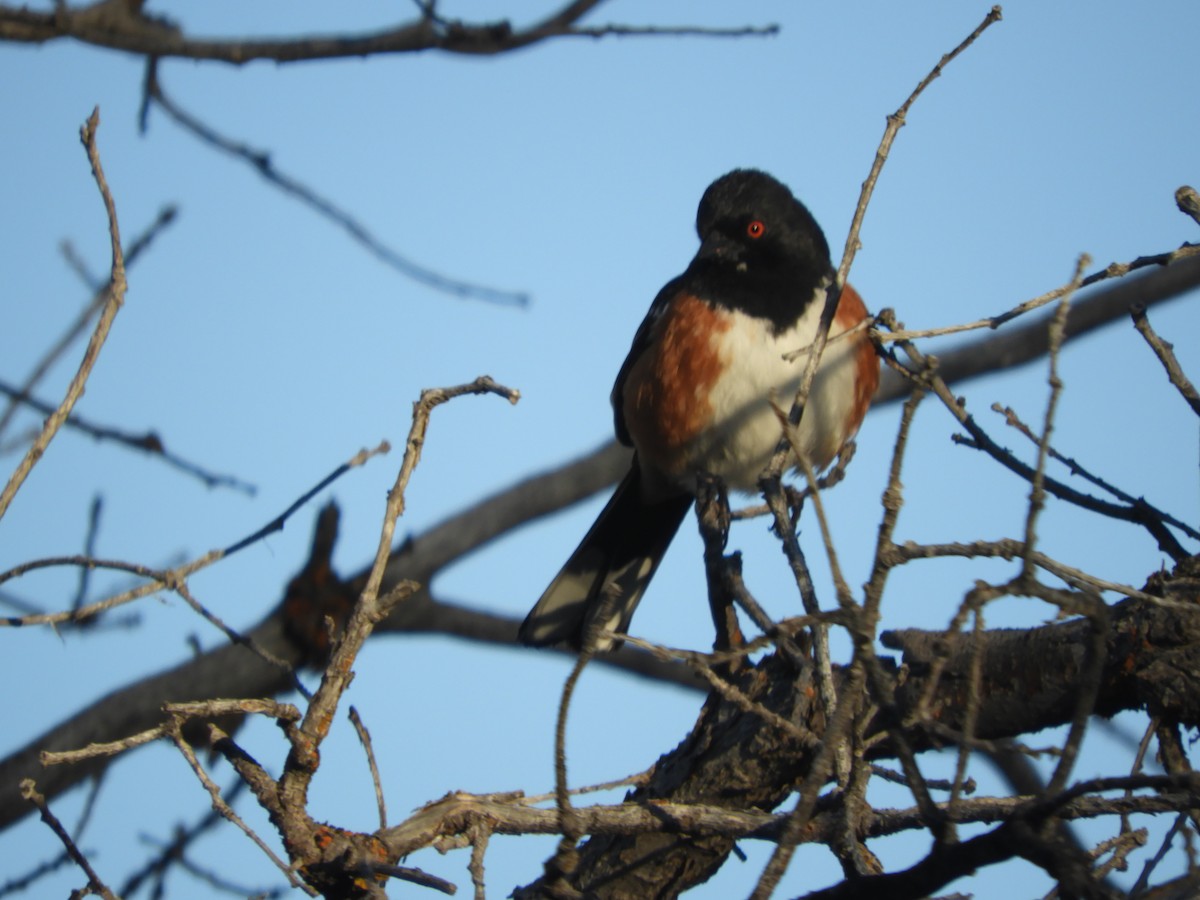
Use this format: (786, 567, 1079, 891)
(688, 169, 834, 329)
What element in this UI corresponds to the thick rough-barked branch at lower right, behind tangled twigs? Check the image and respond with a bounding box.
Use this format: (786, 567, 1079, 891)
(518, 573, 1200, 898)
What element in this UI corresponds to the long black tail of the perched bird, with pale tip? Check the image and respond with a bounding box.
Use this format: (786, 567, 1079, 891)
(518, 463, 692, 650)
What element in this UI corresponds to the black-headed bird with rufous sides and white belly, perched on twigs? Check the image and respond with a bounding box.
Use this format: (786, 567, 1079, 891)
(518, 169, 880, 652)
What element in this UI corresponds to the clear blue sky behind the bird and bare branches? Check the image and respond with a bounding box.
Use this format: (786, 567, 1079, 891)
(0, 0, 1200, 898)
